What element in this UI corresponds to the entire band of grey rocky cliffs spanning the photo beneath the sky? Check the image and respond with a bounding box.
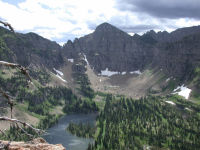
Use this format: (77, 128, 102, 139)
(0, 23, 200, 79)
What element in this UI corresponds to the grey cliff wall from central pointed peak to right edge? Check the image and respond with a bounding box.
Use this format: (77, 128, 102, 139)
(63, 23, 200, 78)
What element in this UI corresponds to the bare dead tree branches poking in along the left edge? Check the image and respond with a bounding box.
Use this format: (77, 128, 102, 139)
(0, 21, 44, 137)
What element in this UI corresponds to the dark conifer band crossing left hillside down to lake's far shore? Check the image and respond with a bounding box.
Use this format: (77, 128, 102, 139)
(0, 66, 98, 115)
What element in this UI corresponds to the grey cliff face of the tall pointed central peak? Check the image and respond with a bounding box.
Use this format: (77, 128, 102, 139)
(63, 23, 152, 72)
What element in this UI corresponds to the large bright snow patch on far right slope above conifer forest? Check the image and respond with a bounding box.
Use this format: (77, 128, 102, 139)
(172, 84, 192, 99)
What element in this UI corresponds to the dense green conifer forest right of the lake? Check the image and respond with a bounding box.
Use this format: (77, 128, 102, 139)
(88, 95, 200, 150)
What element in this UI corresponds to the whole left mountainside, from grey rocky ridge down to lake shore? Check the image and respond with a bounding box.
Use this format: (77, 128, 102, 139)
(0, 28, 98, 140)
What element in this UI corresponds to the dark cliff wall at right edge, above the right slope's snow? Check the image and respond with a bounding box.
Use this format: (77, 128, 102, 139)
(154, 33, 200, 80)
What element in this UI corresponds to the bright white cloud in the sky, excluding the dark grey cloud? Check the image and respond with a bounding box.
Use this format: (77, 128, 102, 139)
(0, 0, 200, 43)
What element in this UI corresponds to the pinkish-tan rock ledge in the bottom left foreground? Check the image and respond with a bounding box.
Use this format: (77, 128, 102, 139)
(0, 138, 65, 150)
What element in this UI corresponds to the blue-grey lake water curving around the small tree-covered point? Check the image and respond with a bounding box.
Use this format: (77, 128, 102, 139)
(43, 114, 97, 150)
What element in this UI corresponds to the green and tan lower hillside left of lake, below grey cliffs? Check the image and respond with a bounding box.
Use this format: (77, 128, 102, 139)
(0, 64, 98, 137)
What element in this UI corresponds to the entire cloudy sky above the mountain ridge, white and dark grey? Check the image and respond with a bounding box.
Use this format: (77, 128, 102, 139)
(0, 0, 200, 44)
